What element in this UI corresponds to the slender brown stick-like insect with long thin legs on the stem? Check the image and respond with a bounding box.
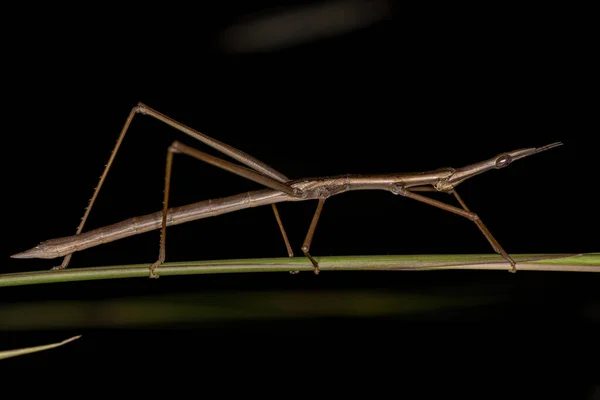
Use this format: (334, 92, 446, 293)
(12, 103, 562, 278)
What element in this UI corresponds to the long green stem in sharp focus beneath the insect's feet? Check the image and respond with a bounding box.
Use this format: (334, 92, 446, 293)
(0, 253, 600, 286)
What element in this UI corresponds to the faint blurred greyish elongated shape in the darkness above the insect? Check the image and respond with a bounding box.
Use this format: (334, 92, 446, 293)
(219, 0, 392, 53)
